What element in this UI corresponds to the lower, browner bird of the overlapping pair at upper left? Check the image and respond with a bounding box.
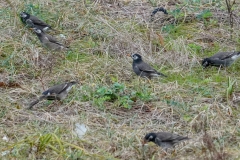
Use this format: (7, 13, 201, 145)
(32, 28, 69, 51)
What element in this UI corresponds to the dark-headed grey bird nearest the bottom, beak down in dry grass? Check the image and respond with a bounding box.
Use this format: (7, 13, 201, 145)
(143, 132, 190, 151)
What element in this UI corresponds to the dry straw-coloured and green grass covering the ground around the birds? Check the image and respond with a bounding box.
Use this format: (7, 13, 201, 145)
(0, 0, 240, 160)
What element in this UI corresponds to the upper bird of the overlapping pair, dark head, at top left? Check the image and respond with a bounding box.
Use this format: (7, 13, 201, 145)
(20, 12, 52, 31)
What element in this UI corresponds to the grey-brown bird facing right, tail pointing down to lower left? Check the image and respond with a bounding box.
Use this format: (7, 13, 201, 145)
(28, 81, 78, 109)
